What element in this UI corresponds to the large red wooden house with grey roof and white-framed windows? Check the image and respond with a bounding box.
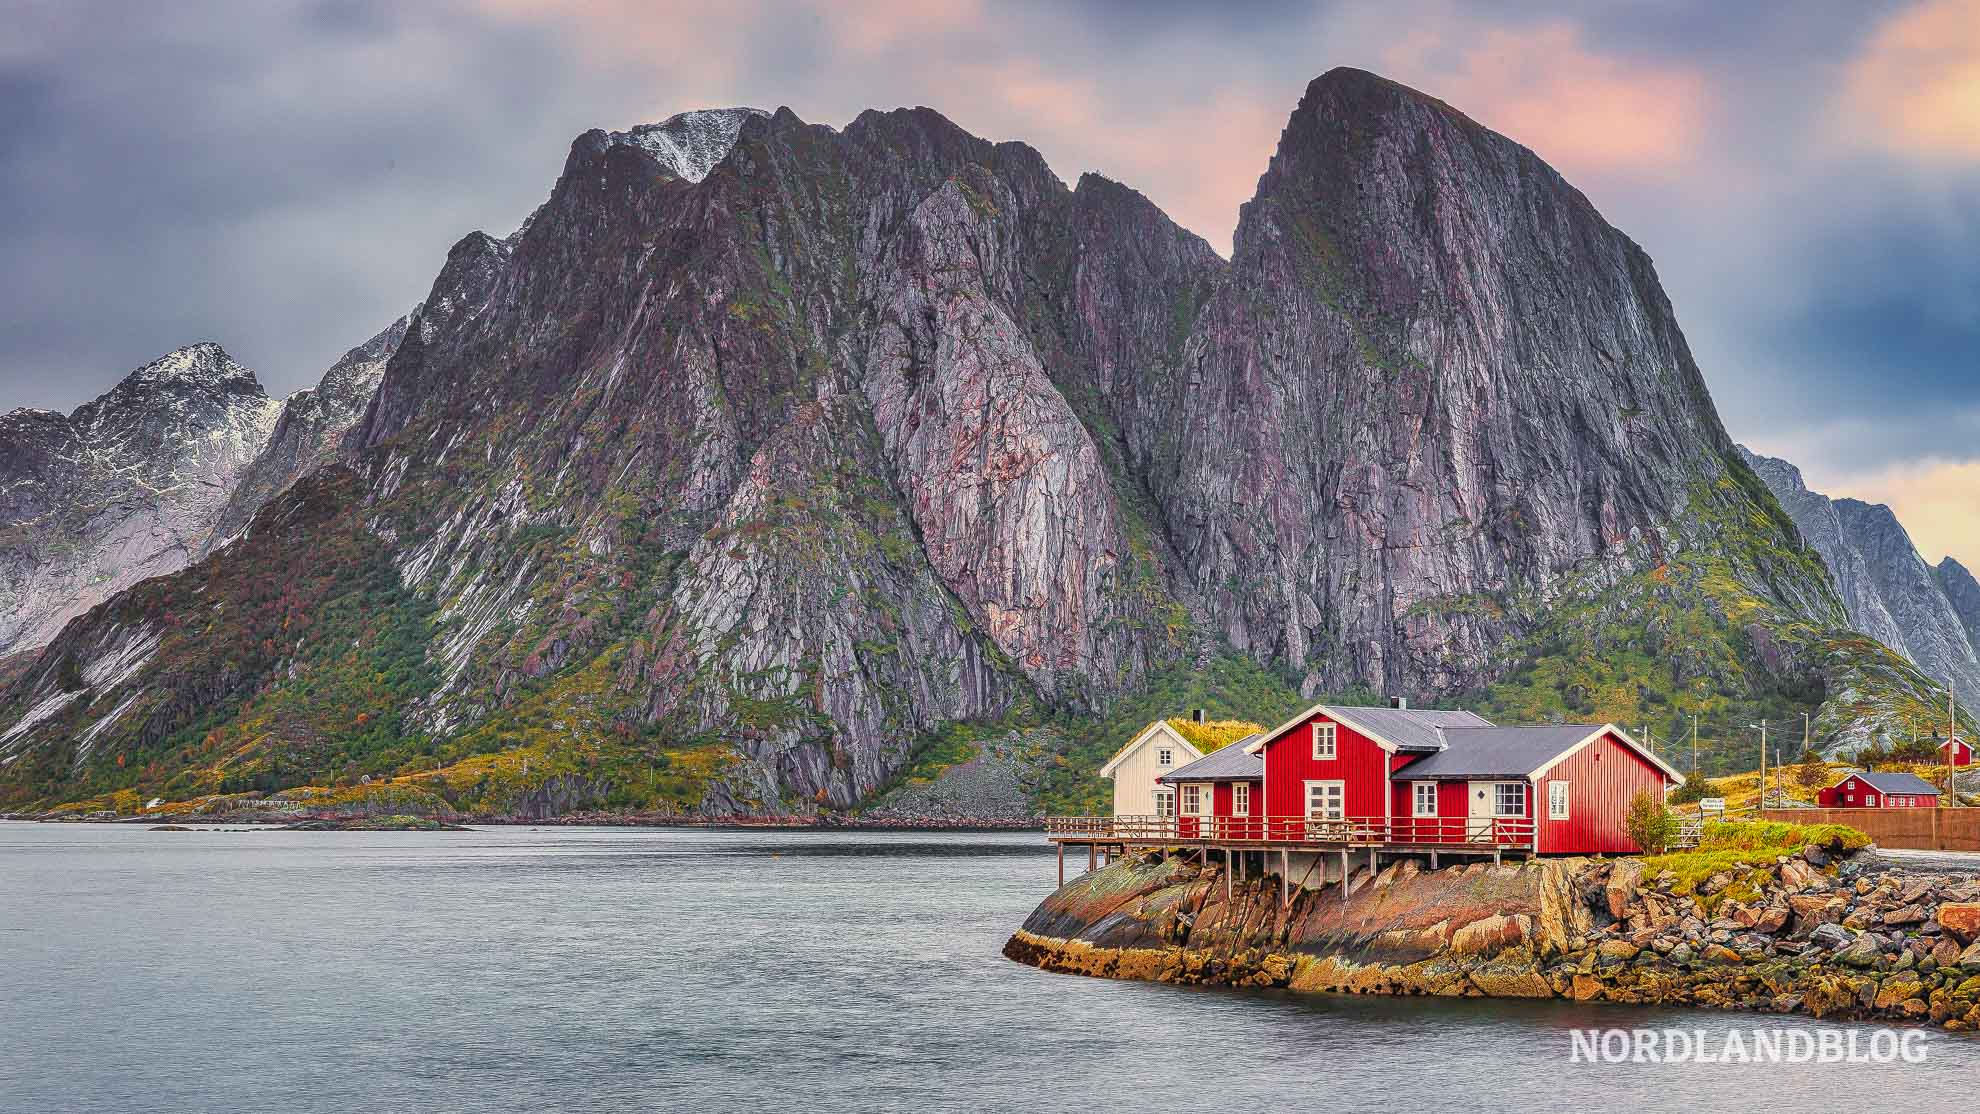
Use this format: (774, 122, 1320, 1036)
(1235, 704, 1683, 855)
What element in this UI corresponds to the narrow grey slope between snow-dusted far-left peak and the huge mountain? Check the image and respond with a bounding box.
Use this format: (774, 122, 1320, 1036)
(200, 307, 420, 556)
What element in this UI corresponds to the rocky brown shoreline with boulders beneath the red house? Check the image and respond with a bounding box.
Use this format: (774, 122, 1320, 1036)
(1004, 845, 1980, 1031)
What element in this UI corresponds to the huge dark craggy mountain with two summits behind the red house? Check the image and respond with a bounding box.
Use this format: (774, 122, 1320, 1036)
(0, 69, 1956, 815)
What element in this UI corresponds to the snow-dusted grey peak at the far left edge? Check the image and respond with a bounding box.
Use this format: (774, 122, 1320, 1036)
(0, 342, 279, 653)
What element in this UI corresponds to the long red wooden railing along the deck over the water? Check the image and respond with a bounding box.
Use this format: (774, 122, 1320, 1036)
(1045, 815, 1535, 847)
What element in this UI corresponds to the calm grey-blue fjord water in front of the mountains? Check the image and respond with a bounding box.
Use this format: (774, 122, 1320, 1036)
(0, 823, 1980, 1112)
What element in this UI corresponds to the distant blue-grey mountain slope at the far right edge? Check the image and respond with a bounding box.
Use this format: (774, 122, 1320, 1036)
(1740, 449, 1980, 693)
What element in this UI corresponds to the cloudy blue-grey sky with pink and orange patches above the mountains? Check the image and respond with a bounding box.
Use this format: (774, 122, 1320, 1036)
(11, 0, 1980, 568)
